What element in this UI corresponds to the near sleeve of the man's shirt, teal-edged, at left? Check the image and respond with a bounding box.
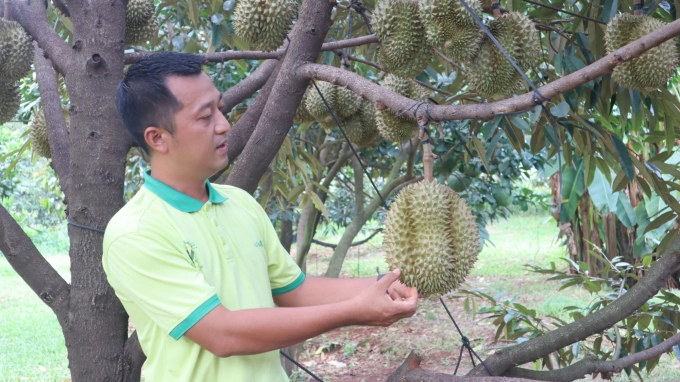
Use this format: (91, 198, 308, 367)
(103, 233, 220, 340)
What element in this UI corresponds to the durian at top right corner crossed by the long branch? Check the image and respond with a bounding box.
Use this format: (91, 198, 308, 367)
(604, 13, 678, 91)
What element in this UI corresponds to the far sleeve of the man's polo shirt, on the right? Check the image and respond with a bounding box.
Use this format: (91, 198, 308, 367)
(249, 195, 305, 296)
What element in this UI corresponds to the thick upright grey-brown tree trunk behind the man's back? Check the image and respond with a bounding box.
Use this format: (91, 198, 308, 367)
(60, 1, 134, 382)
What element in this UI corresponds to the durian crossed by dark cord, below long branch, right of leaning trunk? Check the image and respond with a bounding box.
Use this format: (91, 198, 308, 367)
(305, 81, 361, 131)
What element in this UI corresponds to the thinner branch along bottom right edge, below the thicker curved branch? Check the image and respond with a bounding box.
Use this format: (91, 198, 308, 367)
(505, 333, 680, 382)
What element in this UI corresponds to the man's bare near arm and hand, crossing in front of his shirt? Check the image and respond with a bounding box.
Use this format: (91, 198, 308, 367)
(184, 271, 418, 357)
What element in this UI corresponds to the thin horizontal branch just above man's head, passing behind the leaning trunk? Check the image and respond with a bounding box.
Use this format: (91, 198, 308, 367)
(125, 35, 379, 65)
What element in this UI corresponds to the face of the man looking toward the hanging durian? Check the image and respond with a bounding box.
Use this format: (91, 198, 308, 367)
(166, 72, 231, 178)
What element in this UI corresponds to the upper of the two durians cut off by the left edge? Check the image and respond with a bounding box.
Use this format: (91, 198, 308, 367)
(0, 19, 33, 82)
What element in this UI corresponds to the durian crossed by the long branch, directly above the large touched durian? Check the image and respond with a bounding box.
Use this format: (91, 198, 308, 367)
(375, 74, 427, 142)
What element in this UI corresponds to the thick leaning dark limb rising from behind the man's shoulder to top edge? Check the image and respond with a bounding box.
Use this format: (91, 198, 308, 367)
(227, 1, 333, 193)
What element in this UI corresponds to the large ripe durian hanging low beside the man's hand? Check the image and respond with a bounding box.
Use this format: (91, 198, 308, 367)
(383, 181, 480, 296)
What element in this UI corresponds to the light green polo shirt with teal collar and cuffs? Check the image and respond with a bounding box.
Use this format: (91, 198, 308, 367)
(102, 172, 305, 382)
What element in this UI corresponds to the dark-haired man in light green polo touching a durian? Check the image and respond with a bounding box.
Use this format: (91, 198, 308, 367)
(103, 53, 418, 382)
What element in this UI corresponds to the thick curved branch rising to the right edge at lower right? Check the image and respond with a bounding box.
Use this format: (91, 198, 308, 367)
(468, 235, 680, 375)
